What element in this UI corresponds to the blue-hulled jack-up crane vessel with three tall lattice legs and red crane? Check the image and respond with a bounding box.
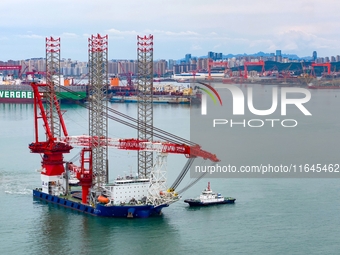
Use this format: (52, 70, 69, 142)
(29, 34, 219, 218)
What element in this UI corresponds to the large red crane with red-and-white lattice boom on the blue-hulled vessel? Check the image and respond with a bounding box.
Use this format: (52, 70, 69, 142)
(29, 83, 219, 203)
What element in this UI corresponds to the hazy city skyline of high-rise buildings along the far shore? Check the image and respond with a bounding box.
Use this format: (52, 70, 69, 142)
(0, 50, 340, 77)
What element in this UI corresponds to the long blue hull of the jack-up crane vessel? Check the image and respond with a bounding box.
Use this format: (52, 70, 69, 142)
(33, 189, 169, 218)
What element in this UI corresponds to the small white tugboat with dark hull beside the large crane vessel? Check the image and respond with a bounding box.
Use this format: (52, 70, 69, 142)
(184, 182, 236, 206)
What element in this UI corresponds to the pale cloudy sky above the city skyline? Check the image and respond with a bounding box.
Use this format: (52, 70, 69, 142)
(0, 0, 340, 61)
